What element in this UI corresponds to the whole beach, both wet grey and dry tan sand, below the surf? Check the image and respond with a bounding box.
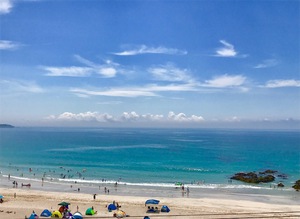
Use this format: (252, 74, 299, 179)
(0, 177, 300, 219)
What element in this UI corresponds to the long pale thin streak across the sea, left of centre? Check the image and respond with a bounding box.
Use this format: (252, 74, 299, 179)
(46, 144, 167, 152)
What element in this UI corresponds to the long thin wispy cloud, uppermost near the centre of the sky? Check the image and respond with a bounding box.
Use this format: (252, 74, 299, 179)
(112, 45, 187, 56)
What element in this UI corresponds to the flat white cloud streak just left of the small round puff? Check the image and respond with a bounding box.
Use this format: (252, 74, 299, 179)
(41, 66, 93, 77)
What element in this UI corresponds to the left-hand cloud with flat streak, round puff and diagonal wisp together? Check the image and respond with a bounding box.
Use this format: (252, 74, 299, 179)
(41, 55, 119, 78)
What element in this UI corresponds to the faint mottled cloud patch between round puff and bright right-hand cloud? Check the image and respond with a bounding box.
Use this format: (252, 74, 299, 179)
(148, 63, 194, 83)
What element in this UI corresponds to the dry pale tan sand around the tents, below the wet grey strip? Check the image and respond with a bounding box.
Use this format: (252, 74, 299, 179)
(0, 181, 300, 219)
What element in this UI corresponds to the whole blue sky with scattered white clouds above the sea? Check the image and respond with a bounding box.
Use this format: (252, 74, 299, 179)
(0, 0, 300, 129)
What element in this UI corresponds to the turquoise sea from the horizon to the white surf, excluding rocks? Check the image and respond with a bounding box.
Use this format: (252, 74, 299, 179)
(0, 128, 300, 191)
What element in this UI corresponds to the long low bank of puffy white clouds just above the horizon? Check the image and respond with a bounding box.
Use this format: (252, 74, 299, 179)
(46, 111, 204, 123)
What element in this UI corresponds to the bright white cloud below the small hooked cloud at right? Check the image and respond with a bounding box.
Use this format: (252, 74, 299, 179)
(202, 74, 246, 88)
